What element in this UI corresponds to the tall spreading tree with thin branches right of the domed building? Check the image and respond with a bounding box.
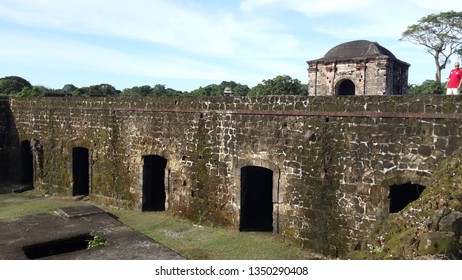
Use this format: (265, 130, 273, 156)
(401, 11, 462, 84)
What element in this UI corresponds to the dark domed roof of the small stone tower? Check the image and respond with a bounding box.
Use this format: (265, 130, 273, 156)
(322, 40, 396, 60)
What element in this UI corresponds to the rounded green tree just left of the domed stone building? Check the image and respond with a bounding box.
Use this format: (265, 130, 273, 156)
(249, 75, 308, 95)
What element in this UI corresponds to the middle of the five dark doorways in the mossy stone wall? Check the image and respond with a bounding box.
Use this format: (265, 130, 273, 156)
(141, 155, 167, 211)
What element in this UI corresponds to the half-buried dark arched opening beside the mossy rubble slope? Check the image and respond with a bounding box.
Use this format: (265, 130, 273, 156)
(388, 183, 425, 213)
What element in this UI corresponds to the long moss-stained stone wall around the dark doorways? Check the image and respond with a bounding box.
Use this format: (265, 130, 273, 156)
(0, 96, 462, 255)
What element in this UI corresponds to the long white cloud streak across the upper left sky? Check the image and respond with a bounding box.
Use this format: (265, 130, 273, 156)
(0, 0, 304, 56)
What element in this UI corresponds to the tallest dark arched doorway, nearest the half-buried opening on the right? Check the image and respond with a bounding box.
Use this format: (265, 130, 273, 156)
(239, 166, 273, 231)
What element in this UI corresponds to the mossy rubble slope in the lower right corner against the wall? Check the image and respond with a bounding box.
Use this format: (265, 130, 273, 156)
(347, 149, 462, 259)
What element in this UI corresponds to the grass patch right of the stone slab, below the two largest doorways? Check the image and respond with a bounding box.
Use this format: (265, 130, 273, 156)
(101, 208, 320, 260)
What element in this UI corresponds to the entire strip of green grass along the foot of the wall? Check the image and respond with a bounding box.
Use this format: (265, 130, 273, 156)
(0, 187, 323, 260)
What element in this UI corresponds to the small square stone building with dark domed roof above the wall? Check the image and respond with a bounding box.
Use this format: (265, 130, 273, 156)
(307, 40, 410, 95)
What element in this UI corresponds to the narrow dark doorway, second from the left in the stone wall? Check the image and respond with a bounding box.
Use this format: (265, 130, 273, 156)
(72, 147, 90, 195)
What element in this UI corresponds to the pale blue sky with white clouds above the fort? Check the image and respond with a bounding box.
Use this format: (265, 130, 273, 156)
(0, 0, 460, 91)
